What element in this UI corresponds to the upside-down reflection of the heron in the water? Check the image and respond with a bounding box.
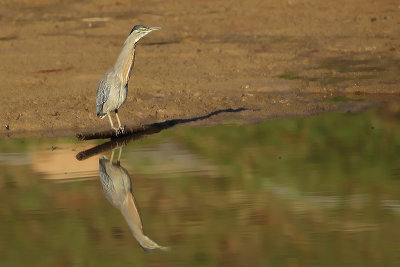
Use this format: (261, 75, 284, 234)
(99, 150, 169, 251)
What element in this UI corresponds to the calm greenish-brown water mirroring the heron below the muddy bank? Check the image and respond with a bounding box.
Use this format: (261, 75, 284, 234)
(0, 108, 400, 266)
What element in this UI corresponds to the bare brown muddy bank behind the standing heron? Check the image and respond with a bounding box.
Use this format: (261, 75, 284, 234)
(0, 0, 400, 137)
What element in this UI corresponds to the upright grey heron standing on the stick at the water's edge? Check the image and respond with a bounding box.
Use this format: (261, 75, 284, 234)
(96, 25, 161, 135)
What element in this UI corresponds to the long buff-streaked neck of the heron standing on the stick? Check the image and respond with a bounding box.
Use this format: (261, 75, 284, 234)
(114, 39, 136, 86)
